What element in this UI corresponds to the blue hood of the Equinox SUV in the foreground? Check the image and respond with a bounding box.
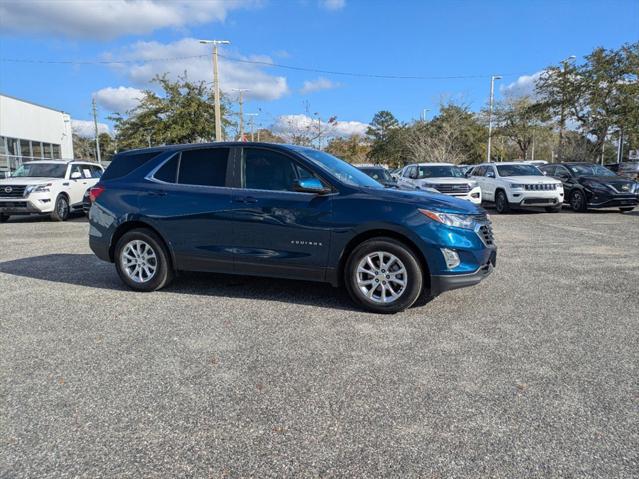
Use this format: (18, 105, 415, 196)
(361, 188, 484, 215)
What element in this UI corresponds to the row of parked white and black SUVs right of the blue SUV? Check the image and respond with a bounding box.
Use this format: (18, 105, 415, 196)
(368, 160, 639, 213)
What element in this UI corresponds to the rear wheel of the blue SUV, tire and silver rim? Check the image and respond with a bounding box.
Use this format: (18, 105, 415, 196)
(114, 229, 173, 292)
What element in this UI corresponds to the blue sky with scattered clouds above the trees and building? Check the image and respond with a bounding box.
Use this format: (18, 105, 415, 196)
(0, 0, 639, 134)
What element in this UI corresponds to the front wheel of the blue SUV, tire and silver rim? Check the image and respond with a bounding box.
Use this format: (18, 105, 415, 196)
(344, 238, 424, 313)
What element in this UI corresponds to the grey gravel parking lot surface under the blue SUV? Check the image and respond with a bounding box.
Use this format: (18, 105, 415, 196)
(0, 212, 639, 478)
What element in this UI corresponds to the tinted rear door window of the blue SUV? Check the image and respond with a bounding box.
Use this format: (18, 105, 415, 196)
(178, 148, 230, 186)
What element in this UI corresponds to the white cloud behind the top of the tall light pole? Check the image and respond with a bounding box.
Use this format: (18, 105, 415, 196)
(105, 38, 289, 100)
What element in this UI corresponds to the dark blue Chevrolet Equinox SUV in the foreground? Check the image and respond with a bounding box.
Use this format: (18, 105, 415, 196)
(89, 143, 496, 313)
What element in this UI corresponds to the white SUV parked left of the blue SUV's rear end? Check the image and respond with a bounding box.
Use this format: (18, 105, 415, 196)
(0, 160, 104, 222)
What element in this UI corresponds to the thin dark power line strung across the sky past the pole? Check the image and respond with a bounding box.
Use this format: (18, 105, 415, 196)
(0, 54, 523, 80)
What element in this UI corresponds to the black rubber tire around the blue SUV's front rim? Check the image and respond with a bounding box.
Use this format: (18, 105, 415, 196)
(344, 237, 424, 314)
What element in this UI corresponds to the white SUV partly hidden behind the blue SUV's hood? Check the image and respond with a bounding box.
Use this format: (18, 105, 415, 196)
(398, 163, 481, 205)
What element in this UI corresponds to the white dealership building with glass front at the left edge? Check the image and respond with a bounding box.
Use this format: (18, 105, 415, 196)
(0, 94, 73, 177)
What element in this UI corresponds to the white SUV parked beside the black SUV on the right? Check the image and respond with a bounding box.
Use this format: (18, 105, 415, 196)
(469, 162, 564, 213)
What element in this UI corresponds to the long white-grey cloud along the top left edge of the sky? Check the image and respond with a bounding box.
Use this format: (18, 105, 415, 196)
(0, 0, 255, 39)
